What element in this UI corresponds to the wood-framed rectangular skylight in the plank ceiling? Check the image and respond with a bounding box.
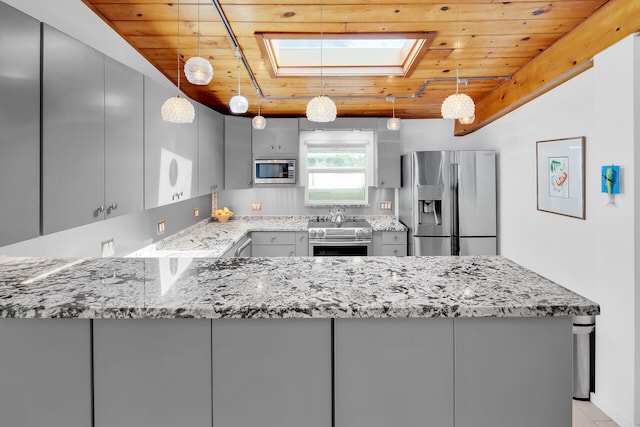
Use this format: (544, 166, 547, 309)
(256, 33, 432, 77)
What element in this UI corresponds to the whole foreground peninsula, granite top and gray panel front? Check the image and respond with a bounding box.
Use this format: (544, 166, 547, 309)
(0, 223, 600, 427)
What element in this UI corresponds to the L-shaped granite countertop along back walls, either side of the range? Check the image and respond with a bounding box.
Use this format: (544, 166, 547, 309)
(129, 215, 407, 257)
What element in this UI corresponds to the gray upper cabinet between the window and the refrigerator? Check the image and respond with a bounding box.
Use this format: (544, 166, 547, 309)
(376, 119, 402, 188)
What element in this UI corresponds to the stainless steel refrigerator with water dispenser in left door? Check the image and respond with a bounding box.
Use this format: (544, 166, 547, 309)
(398, 151, 497, 256)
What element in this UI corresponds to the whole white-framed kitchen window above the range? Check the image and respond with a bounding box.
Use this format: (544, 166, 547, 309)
(300, 131, 373, 206)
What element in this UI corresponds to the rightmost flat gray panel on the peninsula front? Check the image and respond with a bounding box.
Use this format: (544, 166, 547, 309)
(456, 317, 573, 427)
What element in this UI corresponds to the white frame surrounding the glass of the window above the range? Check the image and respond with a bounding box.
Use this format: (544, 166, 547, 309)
(298, 131, 375, 207)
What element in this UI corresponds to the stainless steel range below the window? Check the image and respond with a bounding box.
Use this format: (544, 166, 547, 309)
(309, 220, 373, 256)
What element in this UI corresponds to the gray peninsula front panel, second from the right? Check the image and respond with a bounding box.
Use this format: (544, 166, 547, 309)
(334, 318, 454, 427)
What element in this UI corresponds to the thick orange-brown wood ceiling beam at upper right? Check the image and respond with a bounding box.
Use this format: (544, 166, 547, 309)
(454, 0, 640, 136)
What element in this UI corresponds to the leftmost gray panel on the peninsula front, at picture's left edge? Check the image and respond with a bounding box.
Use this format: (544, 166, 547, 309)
(0, 319, 92, 427)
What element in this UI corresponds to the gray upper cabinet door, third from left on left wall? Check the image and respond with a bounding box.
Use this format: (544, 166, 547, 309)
(104, 58, 144, 218)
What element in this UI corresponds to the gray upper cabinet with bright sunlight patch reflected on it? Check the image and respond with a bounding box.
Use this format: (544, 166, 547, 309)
(144, 77, 198, 209)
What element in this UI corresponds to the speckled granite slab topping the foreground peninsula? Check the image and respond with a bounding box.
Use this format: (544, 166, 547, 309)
(0, 257, 600, 318)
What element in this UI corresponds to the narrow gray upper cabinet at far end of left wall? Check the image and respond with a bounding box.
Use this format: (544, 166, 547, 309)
(198, 105, 224, 195)
